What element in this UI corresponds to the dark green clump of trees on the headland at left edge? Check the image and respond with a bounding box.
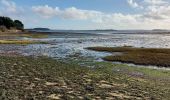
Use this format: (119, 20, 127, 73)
(0, 16, 24, 30)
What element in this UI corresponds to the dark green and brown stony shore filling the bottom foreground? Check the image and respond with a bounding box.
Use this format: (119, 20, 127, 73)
(0, 56, 170, 100)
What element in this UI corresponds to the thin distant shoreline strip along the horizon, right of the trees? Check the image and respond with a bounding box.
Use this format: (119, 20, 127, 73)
(26, 29, 170, 34)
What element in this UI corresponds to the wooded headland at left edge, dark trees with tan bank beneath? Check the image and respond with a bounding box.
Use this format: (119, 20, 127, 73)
(0, 16, 24, 32)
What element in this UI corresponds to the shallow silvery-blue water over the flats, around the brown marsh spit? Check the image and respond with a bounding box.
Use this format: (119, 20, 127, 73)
(0, 33, 170, 69)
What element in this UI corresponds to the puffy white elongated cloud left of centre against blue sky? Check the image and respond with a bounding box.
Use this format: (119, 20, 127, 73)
(32, 5, 101, 20)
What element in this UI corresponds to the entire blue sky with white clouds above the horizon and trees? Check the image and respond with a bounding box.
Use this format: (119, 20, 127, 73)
(0, 0, 170, 30)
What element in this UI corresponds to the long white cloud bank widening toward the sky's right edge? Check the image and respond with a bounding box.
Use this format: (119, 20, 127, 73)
(32, 1, 170, 29)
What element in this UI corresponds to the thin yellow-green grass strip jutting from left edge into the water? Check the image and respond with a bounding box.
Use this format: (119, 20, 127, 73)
(0, 40, 46, 45)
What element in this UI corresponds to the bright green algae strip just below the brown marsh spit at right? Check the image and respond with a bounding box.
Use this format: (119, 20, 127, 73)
(95, 62, 170, 79)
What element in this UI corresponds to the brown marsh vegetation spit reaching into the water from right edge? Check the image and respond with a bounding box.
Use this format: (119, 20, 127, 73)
(87, 47, 170, 67)
